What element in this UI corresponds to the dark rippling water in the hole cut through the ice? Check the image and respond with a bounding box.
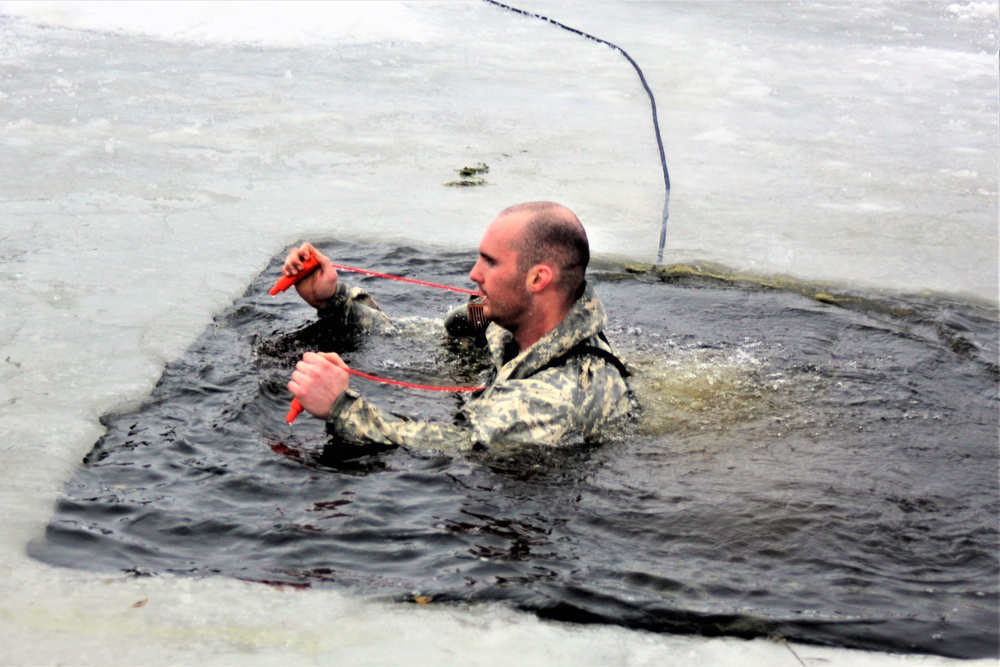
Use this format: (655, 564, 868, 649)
(29, 244, 1000, 657)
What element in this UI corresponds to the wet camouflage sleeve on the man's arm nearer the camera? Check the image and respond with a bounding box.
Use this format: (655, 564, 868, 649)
(327, 358, 627, 451)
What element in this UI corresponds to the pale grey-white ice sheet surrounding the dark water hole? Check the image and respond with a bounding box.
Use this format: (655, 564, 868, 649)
(0, 2, 998, 665)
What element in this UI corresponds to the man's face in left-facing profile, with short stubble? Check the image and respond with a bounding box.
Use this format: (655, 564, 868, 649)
(469, 214, 530, 332)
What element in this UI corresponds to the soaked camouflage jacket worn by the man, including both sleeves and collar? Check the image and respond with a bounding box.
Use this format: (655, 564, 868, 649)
(322, 286, 630, 450)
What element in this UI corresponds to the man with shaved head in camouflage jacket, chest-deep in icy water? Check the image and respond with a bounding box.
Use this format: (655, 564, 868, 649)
(282, 202, 629, 449)
